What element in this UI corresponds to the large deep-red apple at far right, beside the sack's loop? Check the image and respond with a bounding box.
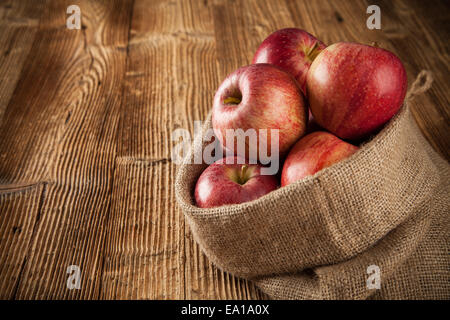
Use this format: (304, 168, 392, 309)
(306, 42, 407, 140)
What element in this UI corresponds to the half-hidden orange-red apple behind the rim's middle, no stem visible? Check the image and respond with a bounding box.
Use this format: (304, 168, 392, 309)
(281, 131, 359, 186)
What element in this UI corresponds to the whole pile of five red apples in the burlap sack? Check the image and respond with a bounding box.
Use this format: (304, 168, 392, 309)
(195, 28, 407, 208)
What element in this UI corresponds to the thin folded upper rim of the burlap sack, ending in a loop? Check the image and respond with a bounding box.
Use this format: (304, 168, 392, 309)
(175, 70, 433, 219)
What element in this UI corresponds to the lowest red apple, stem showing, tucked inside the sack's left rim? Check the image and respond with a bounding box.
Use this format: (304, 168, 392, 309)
(195, 157, 278, 208)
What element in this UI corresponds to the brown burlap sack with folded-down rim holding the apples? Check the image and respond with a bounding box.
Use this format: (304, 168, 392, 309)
(175, 72, 450, 299)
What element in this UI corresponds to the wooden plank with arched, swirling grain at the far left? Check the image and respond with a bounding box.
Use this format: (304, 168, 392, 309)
(0, 1, 131, 299)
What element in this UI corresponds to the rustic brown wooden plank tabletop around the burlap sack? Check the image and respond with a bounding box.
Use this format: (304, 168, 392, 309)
(0, 0, 450, 299)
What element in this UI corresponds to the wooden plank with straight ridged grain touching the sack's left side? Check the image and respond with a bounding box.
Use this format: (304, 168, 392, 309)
(102, 1, 264, 299)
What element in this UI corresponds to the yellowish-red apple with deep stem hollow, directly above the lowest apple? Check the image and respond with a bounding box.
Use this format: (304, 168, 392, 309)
(212, 64, 308, 160)
